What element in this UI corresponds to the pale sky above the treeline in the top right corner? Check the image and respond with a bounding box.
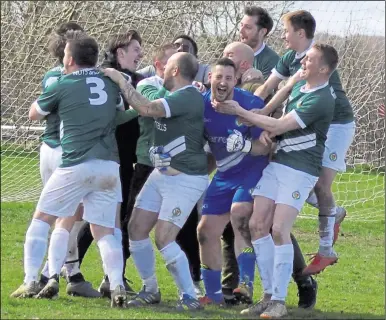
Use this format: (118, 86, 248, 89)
(291, 1, 385, 36)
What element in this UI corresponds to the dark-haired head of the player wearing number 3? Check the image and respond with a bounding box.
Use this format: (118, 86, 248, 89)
(66, 30, 99, 67)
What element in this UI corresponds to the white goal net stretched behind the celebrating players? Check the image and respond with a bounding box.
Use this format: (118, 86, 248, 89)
(1, 1, 385, 220)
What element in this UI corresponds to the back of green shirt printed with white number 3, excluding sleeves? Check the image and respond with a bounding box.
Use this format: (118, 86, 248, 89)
(58, 68, 120, 167)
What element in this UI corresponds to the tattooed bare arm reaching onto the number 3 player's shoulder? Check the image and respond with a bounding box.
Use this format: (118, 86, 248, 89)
(102, 68, 166, 118)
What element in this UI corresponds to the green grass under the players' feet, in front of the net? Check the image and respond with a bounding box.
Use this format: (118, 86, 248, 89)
(1, 203, 385, 319)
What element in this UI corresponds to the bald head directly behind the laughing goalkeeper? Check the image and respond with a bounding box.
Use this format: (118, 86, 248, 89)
(223, 42, 255, 76)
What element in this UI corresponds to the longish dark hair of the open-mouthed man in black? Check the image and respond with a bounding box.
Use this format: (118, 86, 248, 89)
(104, 30, 142, 70)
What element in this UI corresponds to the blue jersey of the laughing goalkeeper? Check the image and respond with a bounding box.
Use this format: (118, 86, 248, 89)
(203, 88, 268, 176)
